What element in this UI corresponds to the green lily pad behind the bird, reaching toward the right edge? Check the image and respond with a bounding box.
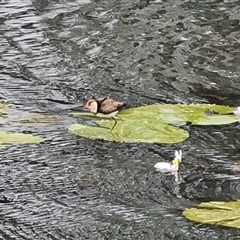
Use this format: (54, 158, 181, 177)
(74, 104, 236, 126)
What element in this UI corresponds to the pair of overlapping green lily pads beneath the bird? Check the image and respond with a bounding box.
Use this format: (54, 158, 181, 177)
(69, 104, 237, 143)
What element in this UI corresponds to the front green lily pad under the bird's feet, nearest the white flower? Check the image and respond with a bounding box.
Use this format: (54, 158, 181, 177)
(69, 120, 189, 143)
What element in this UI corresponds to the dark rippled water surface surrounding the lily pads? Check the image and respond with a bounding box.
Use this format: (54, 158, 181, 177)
(0, 0, 240, 240)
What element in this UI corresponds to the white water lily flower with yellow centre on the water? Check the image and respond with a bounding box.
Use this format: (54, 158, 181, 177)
(154, 150, 182, 174)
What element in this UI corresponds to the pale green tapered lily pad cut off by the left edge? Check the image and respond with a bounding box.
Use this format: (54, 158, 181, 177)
(0, 131, 43, 146)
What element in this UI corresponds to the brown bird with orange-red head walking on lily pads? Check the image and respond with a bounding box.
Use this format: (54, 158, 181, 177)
(84, 97, 125, 132)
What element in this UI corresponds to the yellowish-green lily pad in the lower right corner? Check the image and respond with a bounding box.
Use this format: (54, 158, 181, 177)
(183, 200, 240, 228)
